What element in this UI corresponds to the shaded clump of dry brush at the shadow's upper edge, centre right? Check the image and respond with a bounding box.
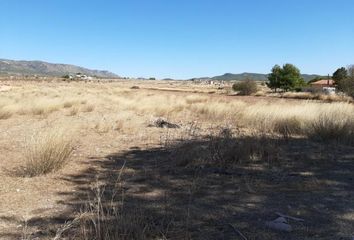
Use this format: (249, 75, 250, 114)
(170, 128, 279, 169)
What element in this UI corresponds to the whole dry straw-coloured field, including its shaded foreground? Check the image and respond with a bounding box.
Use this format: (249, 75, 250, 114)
(0, 80, 354, 240)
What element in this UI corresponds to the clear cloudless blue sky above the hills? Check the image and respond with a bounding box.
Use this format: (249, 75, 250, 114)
(0, 0, 354, 78)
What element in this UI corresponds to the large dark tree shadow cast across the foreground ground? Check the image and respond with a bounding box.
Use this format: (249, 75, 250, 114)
(0, 134, 354, 240)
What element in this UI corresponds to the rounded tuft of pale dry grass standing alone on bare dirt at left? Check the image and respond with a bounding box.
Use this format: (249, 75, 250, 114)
(20, 130, 73, 177)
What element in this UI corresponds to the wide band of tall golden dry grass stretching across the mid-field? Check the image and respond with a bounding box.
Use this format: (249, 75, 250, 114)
(0, 83, 354, 141)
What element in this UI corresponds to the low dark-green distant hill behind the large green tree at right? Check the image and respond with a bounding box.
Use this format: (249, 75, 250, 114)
(193, 73, 322, 82)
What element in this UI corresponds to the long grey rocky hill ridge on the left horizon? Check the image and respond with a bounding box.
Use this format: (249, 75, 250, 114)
(0, 59, 119, 78)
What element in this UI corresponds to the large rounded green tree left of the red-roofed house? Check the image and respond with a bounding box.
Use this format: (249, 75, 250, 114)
(267, 63, 305, 91)
